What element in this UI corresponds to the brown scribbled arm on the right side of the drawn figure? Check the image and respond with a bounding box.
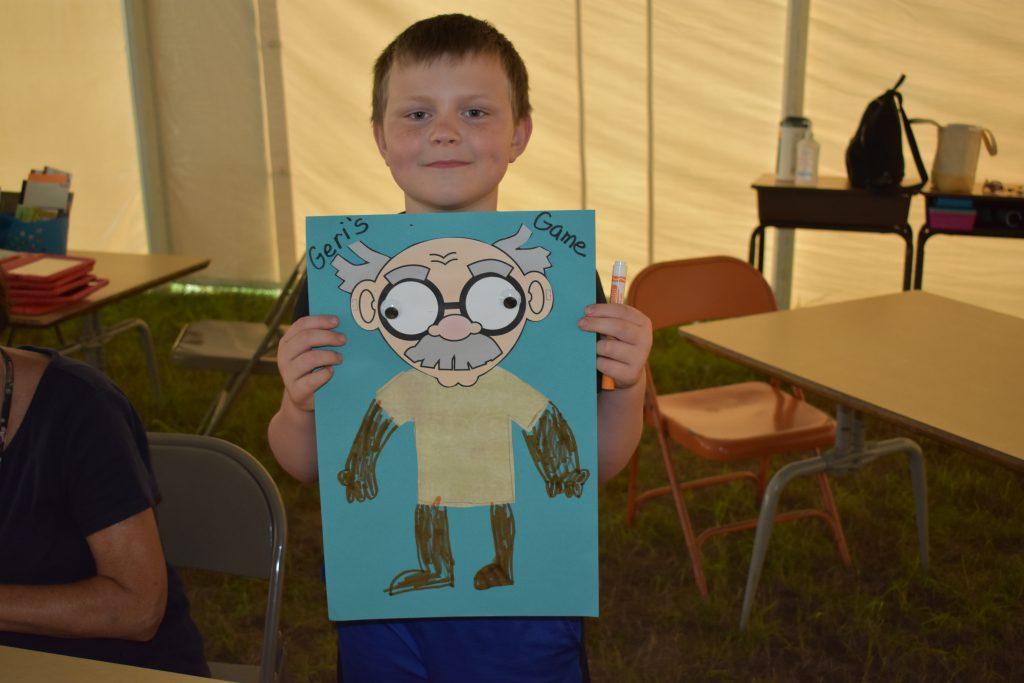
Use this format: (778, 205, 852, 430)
(522, 401, 590, 498)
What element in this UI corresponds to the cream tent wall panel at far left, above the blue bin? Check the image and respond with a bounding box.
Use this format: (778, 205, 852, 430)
(0, 0, 147, 253)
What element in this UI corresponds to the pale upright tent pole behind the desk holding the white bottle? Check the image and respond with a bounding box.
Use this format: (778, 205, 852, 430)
(772, 0, 811, 308)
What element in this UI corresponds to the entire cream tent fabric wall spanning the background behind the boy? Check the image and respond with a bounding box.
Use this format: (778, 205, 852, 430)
(0, 0, 1024, 315)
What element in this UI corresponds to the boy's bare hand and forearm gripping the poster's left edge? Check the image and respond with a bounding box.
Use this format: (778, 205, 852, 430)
(267, 315, 345, 481)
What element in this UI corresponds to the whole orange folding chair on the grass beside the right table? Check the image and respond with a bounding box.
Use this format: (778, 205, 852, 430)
(626, 256, 850, 597)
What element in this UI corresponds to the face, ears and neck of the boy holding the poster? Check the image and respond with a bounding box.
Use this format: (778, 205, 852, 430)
(374, 55, 532, 213)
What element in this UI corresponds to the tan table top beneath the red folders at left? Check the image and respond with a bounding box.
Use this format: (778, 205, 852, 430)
(11, 251, 210, 328)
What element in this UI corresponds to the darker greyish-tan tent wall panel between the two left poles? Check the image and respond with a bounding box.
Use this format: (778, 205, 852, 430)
(130, 0, 280, 282)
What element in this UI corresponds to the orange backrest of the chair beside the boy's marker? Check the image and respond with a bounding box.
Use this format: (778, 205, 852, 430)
(626, 256, 776, 330)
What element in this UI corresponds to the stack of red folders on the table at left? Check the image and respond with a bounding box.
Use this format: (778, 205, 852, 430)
(0, 253, 110, 315)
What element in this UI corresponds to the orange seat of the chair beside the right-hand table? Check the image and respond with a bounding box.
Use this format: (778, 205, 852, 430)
(657, 382, 836, 461)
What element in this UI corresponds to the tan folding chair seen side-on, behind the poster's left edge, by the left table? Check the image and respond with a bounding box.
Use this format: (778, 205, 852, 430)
(171, 258, 306, 434)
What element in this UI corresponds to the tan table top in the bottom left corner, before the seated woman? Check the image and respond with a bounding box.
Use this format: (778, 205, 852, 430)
(0, 645, 223, 683)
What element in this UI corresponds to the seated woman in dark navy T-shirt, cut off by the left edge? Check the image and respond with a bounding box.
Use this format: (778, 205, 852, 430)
(0, 275, 209, 678)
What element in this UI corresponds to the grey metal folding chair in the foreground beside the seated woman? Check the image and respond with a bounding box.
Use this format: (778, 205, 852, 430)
(148, 432, 288, 683)
